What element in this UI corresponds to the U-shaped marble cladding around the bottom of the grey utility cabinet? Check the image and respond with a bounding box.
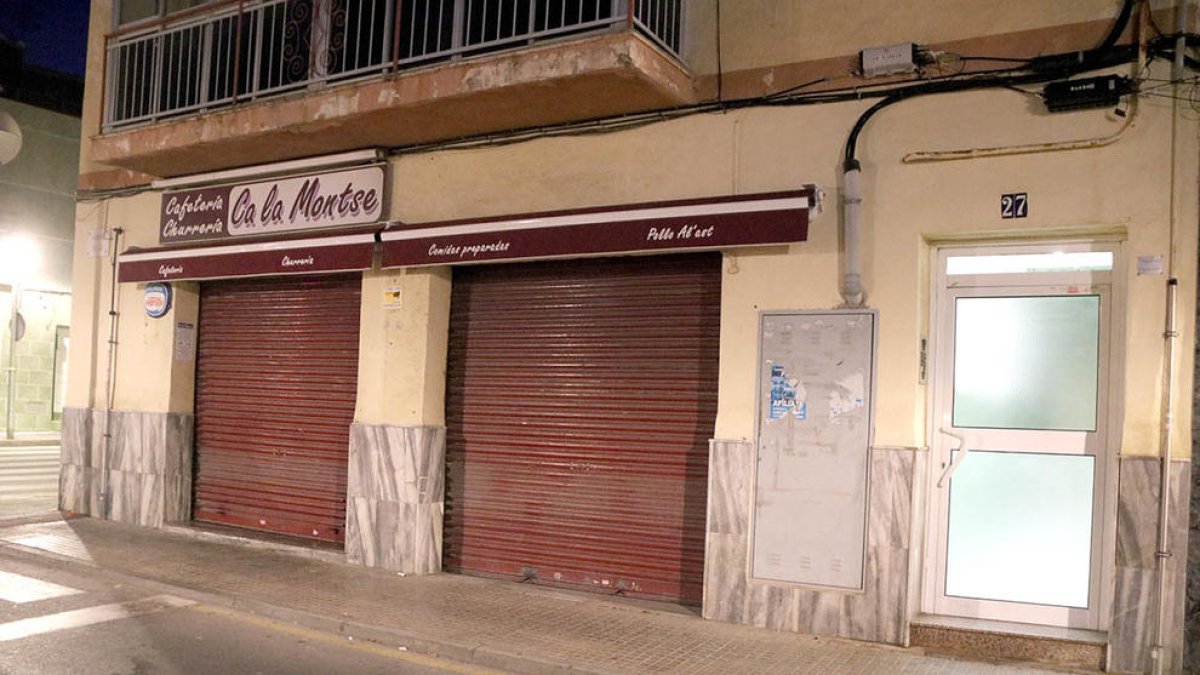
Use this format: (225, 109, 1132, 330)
(703, 440, 916, 644)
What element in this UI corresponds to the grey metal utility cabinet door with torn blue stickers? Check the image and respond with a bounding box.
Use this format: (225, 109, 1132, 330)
(751, 310, 878, 590)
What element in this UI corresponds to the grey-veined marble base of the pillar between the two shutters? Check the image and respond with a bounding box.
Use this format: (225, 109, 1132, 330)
(346, 423, 446, 574)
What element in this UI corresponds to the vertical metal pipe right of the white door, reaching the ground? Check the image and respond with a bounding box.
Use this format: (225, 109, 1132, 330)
(1150, 277, 1180, 675)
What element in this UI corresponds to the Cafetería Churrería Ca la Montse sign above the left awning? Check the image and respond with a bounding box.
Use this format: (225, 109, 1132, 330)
(158, 167, 384, 244)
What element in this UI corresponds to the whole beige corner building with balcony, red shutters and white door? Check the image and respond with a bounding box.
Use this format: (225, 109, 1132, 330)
(61, 0, 1200, 673)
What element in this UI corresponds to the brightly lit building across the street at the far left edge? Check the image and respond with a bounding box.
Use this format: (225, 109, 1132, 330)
(0, 37, 83, 437)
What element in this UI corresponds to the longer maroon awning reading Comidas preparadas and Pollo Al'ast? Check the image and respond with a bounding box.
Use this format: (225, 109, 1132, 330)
(382, 187, 817, 268)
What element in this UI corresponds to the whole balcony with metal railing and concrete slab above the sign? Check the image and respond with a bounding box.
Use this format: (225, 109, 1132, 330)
(92, 0, 694, 181)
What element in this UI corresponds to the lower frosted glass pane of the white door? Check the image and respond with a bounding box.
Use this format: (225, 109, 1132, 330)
(946, 450, 1096, 608)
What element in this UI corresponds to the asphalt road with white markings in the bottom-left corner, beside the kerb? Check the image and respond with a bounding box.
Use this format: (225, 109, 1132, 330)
(0, 554, 491, 675)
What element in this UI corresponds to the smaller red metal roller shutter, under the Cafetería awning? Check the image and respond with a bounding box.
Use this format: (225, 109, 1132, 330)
(193, 275, 361, 542)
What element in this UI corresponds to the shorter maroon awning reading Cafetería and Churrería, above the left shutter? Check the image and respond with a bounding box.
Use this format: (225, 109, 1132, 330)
(118, 229, 376, 281)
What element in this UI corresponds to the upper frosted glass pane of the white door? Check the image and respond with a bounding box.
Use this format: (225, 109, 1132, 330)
(954, 295, 1100, 431)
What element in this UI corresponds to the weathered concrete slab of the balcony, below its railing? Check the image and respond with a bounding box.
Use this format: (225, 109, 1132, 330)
(91, 32, 695, 178)
